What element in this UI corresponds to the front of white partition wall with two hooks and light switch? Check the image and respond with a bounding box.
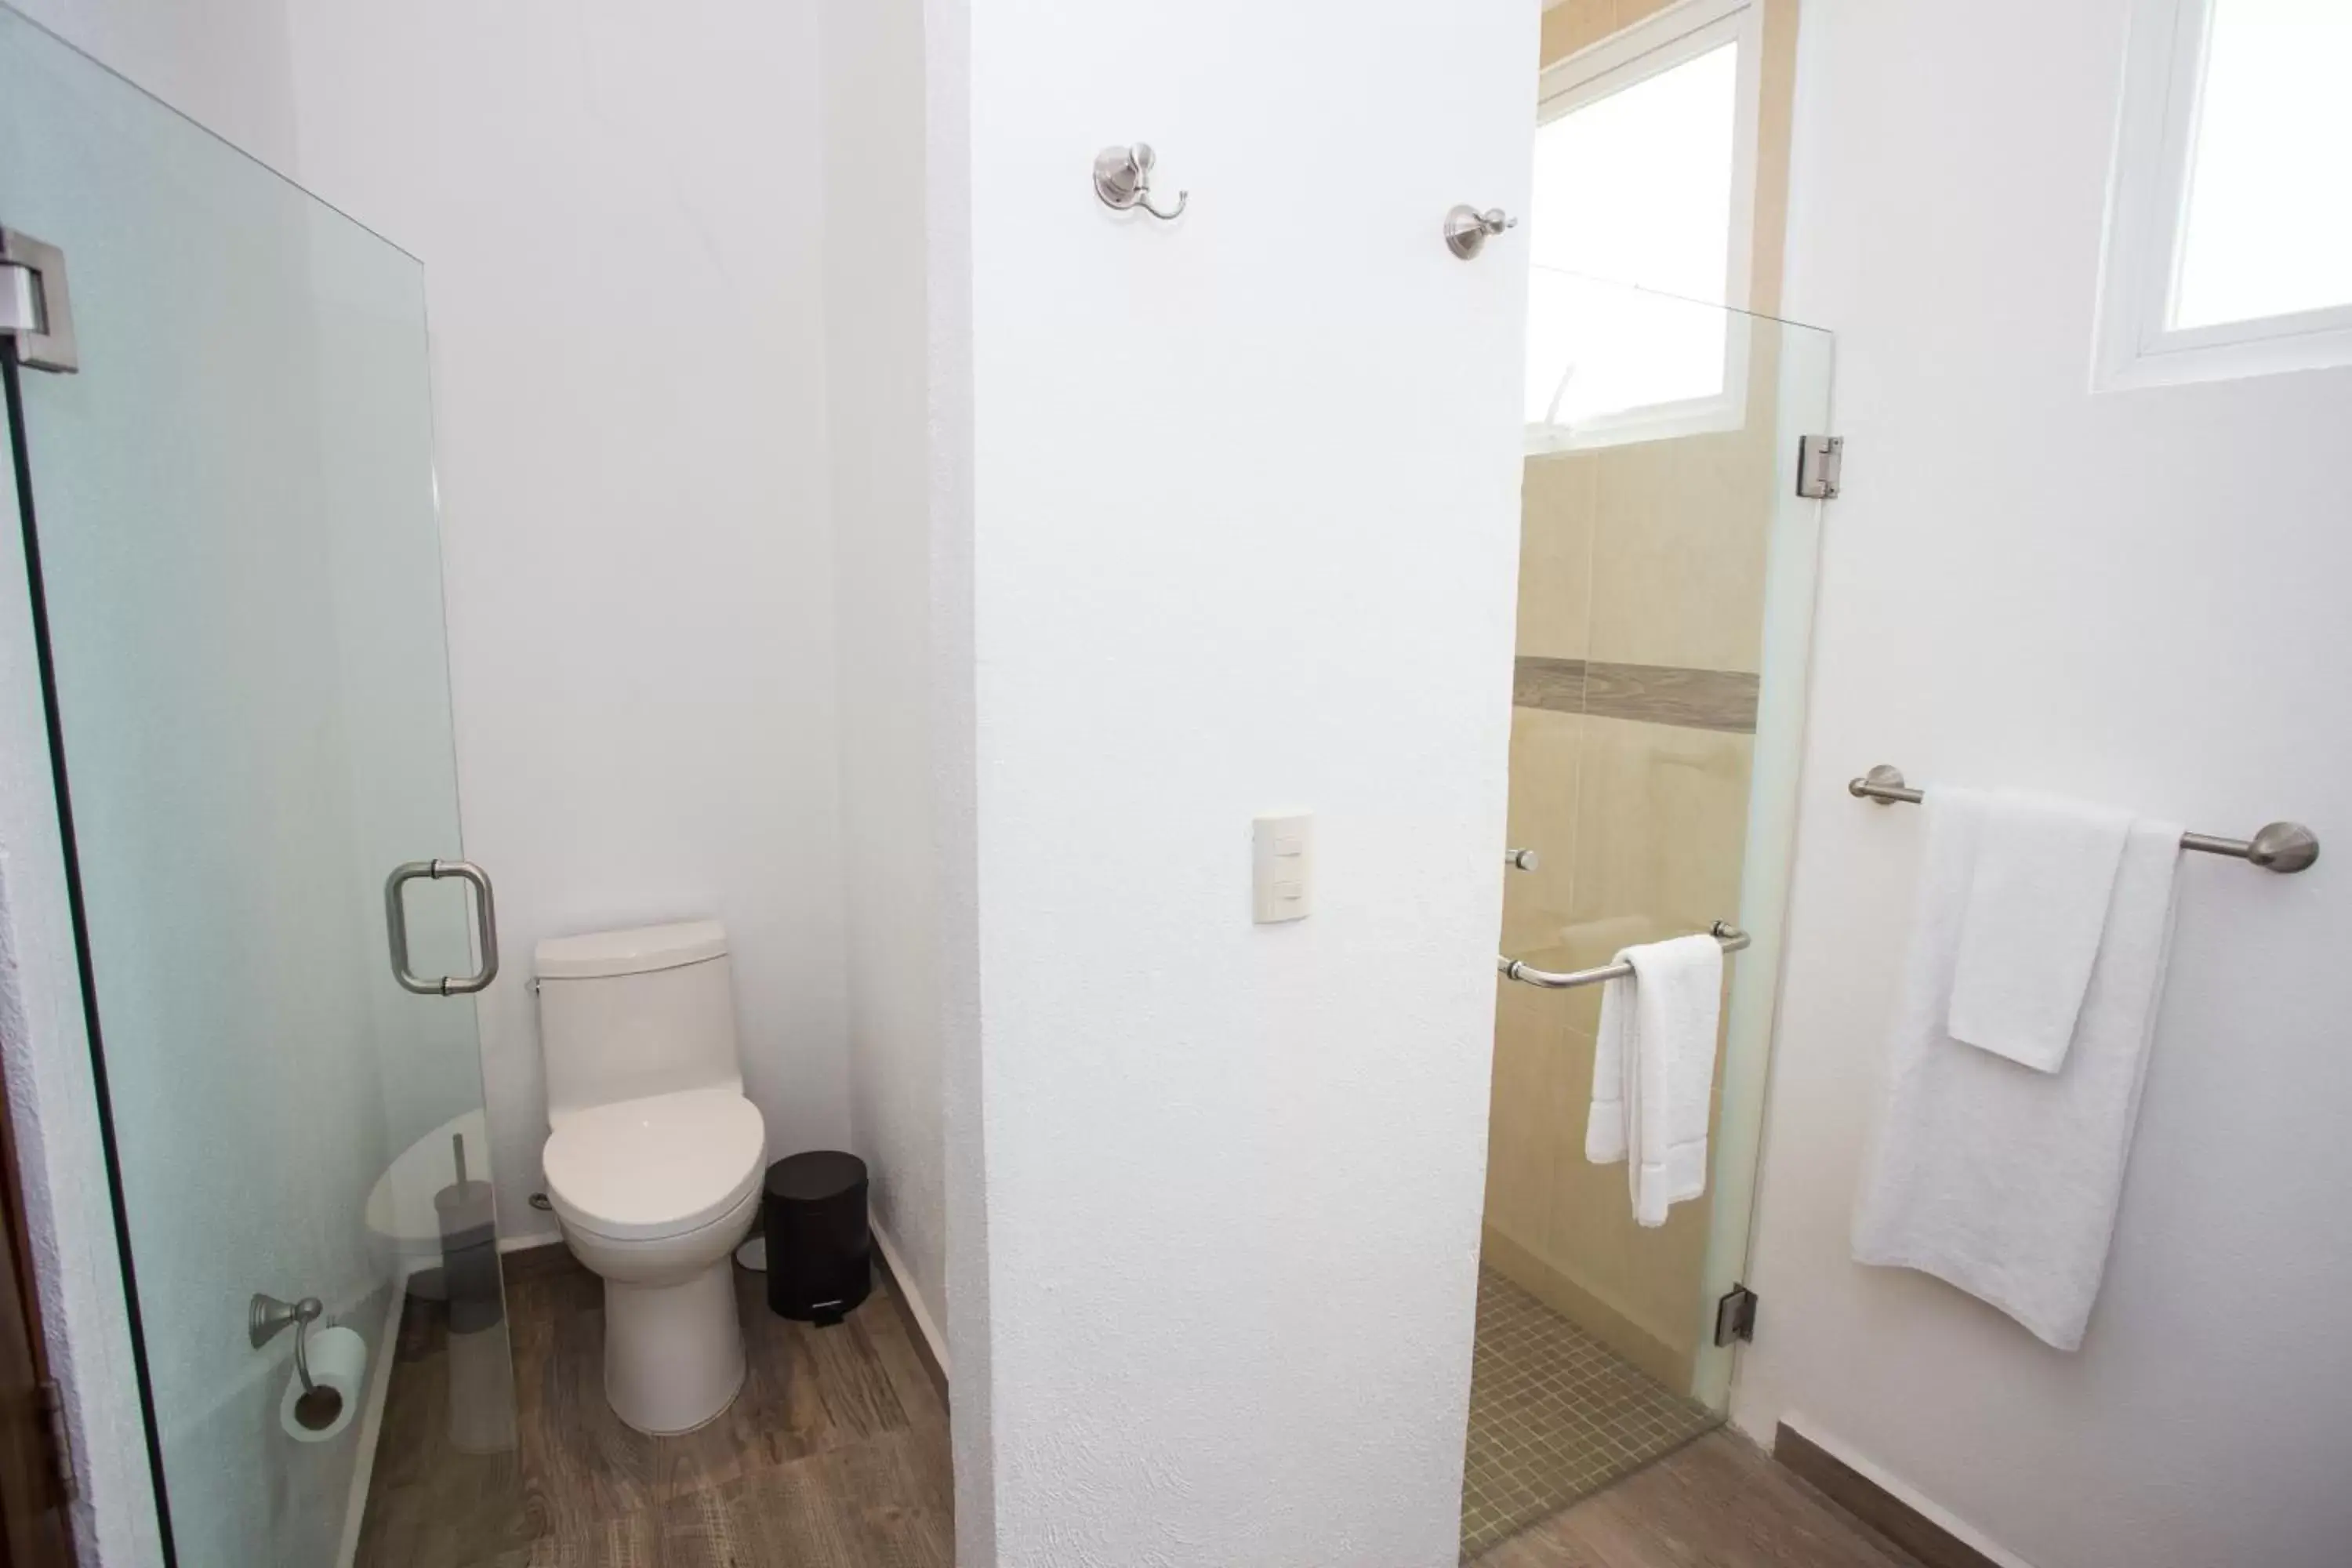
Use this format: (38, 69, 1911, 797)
(950, 0, 1536, 1568)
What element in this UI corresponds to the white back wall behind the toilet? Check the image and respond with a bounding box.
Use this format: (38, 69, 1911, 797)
(273, 0, 849, 1234)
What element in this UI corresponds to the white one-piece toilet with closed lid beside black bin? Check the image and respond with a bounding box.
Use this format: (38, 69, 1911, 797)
(536, 919, 767, 1434)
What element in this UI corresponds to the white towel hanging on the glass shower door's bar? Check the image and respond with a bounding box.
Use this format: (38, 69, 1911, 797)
(1585, 935, 1724, 1225)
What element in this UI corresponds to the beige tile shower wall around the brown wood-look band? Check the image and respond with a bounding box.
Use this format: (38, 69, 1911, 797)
(1486, 0, 1795, 1389)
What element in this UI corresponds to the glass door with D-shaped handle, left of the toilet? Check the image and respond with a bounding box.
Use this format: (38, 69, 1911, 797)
(0, 9, 520, 1568)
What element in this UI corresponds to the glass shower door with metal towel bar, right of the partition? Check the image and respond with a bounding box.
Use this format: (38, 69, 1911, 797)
(1465, 268, 1832, 1547)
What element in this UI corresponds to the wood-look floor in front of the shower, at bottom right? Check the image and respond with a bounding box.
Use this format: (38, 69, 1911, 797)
(1472, 1432, 1917, 1568)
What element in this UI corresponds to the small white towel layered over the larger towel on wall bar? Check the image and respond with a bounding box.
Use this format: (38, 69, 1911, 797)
(1950, 789, 2131, 1072)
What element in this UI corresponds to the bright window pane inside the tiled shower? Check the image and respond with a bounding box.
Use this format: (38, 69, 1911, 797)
(1526, 42, 1738, 428)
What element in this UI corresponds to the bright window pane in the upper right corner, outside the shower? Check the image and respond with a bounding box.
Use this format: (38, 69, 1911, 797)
(2164, 0, 2352, 329)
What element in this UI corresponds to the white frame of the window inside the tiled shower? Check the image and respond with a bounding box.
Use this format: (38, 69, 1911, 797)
(1526, 0, 1764, 456)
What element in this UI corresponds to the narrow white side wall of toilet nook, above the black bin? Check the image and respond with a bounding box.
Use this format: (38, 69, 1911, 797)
(821, 0, 948, 1323)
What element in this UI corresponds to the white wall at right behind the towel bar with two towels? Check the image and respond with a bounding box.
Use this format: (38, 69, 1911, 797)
(1736, 0, 2352, 1568)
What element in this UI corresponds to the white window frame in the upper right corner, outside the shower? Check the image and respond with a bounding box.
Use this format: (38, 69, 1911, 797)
(2091, 0, 2352, 390)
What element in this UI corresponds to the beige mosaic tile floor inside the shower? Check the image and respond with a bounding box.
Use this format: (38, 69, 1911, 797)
(1463, 1269, 1717, 1563)
